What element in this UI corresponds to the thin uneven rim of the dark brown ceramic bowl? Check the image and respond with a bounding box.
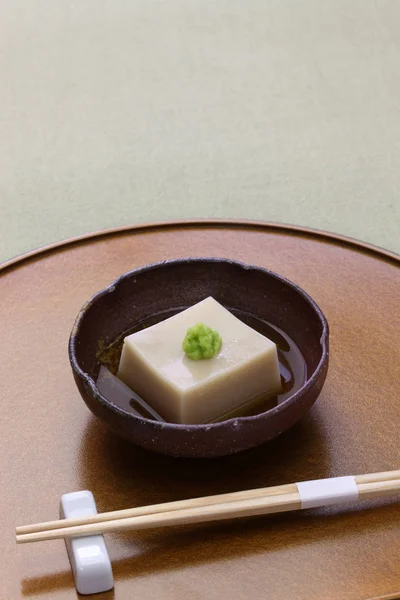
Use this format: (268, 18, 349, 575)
(68, 257, 329, 433)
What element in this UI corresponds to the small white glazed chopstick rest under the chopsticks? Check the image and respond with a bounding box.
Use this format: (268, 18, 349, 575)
(60, 491, 114, 594)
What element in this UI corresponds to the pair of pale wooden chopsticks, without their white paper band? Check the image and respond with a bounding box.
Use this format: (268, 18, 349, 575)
(16, 470, 400, 543)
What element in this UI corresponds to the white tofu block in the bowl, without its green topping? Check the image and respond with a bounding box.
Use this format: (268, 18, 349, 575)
(117, 297, 281, 424)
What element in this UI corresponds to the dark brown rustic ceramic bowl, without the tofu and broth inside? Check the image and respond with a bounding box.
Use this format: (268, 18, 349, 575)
(69, 258, 329, 457)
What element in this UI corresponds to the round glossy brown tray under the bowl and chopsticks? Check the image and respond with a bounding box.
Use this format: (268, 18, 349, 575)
(0, 222, 400, 600)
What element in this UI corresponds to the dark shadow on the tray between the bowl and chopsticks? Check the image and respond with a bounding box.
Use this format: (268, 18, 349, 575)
(80, 408, 330, 511)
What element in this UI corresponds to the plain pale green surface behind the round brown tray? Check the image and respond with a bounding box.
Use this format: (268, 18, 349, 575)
(0, 0, 400, 260)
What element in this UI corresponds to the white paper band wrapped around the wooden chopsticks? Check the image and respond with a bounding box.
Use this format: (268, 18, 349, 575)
(296, 475, 358, 508)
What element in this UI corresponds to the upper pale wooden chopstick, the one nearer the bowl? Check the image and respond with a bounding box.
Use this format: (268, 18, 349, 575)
(15, 470, 400, 535)
